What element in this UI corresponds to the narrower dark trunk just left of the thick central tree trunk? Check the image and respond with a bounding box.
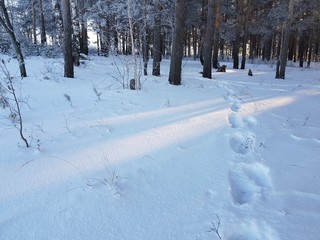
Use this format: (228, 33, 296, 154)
(152, 1, 162, 76)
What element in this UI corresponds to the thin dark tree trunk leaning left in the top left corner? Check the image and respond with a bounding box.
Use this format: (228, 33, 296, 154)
(0, 0, 27, 77)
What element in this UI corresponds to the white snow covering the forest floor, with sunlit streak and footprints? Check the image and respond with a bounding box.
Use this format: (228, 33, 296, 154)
(0, 55, 320, 240)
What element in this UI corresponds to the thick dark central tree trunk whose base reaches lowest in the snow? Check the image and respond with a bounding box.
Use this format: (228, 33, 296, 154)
(169, 0, 185, 85)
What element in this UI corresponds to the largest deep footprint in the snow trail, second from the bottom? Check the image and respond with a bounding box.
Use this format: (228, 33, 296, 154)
(229, 163, 272, 205)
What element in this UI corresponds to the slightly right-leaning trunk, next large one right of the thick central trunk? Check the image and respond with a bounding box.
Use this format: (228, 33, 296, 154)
(202, 0, 215, 79)
